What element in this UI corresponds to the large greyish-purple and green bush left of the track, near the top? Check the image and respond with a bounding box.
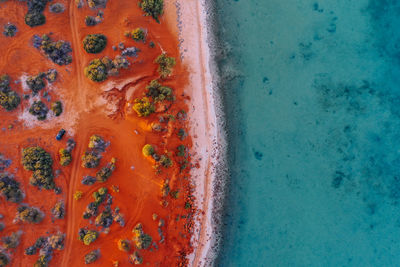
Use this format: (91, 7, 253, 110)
(33, 34, 72, 66)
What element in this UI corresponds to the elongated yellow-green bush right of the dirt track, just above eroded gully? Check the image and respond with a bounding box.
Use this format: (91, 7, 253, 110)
(84, 55, 129, 82)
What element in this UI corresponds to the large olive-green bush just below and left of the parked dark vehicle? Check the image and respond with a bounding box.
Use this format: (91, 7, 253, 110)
(22, 146, 55, 190)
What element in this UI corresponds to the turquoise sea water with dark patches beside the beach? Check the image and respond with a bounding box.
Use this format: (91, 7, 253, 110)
(216, 0, 400, 267)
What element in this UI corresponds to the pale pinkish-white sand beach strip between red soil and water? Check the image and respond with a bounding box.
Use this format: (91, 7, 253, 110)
(171, 0, 226, 267)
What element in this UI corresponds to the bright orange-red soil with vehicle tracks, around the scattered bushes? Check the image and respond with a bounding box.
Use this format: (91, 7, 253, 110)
(0, 0, 193, 267)
